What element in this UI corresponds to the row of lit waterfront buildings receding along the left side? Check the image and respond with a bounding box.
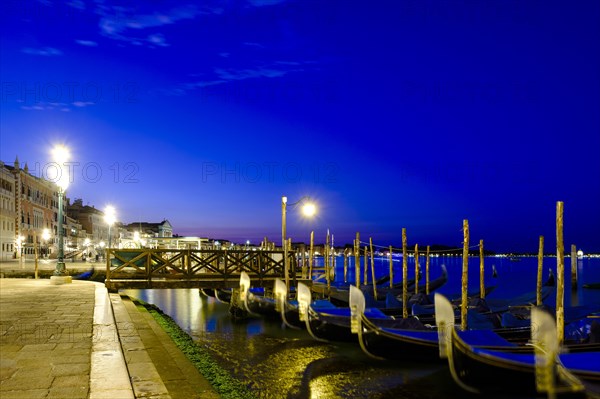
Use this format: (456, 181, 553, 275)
(0, 157, 173, 260)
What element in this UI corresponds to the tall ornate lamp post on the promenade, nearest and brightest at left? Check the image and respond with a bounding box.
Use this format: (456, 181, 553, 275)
(50, 146, 71, 284)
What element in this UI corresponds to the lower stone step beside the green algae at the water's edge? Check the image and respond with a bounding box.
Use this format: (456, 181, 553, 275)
(122, 296, 220, 399)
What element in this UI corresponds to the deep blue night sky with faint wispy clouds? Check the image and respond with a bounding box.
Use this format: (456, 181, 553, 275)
(0, 0, 600, 252)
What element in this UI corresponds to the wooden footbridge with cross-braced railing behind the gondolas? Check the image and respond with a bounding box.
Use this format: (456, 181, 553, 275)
(105, 248, 300, 290)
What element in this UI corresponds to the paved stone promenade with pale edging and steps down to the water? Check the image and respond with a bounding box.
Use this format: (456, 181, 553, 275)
(0, 278, 218, 399)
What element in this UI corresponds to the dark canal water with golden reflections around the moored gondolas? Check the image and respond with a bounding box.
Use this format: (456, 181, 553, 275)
(123, 257, 600, 399)
